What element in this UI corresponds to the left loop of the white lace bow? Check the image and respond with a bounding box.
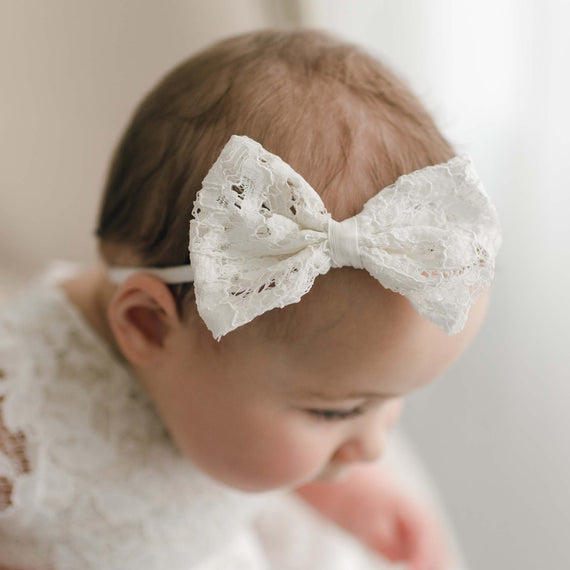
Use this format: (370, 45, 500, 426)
(189, 135, 331, 339)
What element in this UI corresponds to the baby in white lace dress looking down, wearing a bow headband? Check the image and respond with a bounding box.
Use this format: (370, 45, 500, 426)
(0, 29, 494, 570)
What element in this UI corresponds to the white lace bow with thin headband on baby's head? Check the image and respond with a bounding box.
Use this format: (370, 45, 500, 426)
(109, 135, 502, 340)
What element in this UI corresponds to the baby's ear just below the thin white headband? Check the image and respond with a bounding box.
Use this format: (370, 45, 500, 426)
(107, 273, 181, 365)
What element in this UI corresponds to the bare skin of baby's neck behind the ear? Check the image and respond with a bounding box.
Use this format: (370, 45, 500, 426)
(59, 268, 125, 361)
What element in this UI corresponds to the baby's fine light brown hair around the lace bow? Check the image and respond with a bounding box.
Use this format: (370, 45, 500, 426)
(96, 28, 455, 336)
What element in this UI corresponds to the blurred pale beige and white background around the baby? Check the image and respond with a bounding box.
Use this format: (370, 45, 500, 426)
(0, 0, 570, 570)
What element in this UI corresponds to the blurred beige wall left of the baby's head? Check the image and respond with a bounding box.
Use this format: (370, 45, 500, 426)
(0, 0, 279, 287)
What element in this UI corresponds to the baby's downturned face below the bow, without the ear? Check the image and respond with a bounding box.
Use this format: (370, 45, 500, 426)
(145, 272, 489, 491)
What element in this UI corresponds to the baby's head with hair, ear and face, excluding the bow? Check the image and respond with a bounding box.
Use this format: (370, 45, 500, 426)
(93, 29, 488, 491)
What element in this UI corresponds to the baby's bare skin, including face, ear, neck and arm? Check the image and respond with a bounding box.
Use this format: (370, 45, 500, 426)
(61, 262, 489, 570)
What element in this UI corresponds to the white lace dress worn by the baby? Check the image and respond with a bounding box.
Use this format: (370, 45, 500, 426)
(0, 262, 402, 570)
